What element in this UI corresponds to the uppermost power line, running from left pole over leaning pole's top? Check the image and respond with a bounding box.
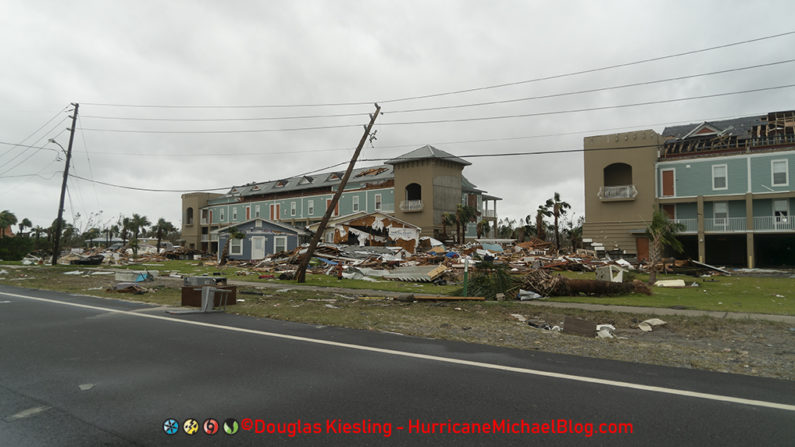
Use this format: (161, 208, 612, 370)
(81, 31, 795, 109)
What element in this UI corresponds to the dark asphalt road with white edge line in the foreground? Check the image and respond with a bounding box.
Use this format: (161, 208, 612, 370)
(0, 286, 795, 446)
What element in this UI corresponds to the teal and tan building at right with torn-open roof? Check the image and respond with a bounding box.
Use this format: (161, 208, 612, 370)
(583, 111, 795, 267)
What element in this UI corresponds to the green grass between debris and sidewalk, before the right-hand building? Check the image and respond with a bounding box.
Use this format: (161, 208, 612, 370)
(549, 272, 795, 315)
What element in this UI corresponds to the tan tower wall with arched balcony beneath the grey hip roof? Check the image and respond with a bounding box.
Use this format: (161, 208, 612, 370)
(393, 159, 464, 240)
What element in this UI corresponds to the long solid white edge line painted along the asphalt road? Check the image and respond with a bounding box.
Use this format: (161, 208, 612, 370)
(2, 292, 795, 411)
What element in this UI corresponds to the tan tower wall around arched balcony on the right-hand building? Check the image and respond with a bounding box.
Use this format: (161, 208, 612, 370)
(583, 130, 662, 253)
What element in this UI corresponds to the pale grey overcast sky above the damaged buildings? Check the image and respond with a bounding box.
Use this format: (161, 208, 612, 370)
(0, 0, 795, 236)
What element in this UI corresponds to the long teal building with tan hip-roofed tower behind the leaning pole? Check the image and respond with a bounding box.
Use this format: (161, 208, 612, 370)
(182, 146, 500, 252)
